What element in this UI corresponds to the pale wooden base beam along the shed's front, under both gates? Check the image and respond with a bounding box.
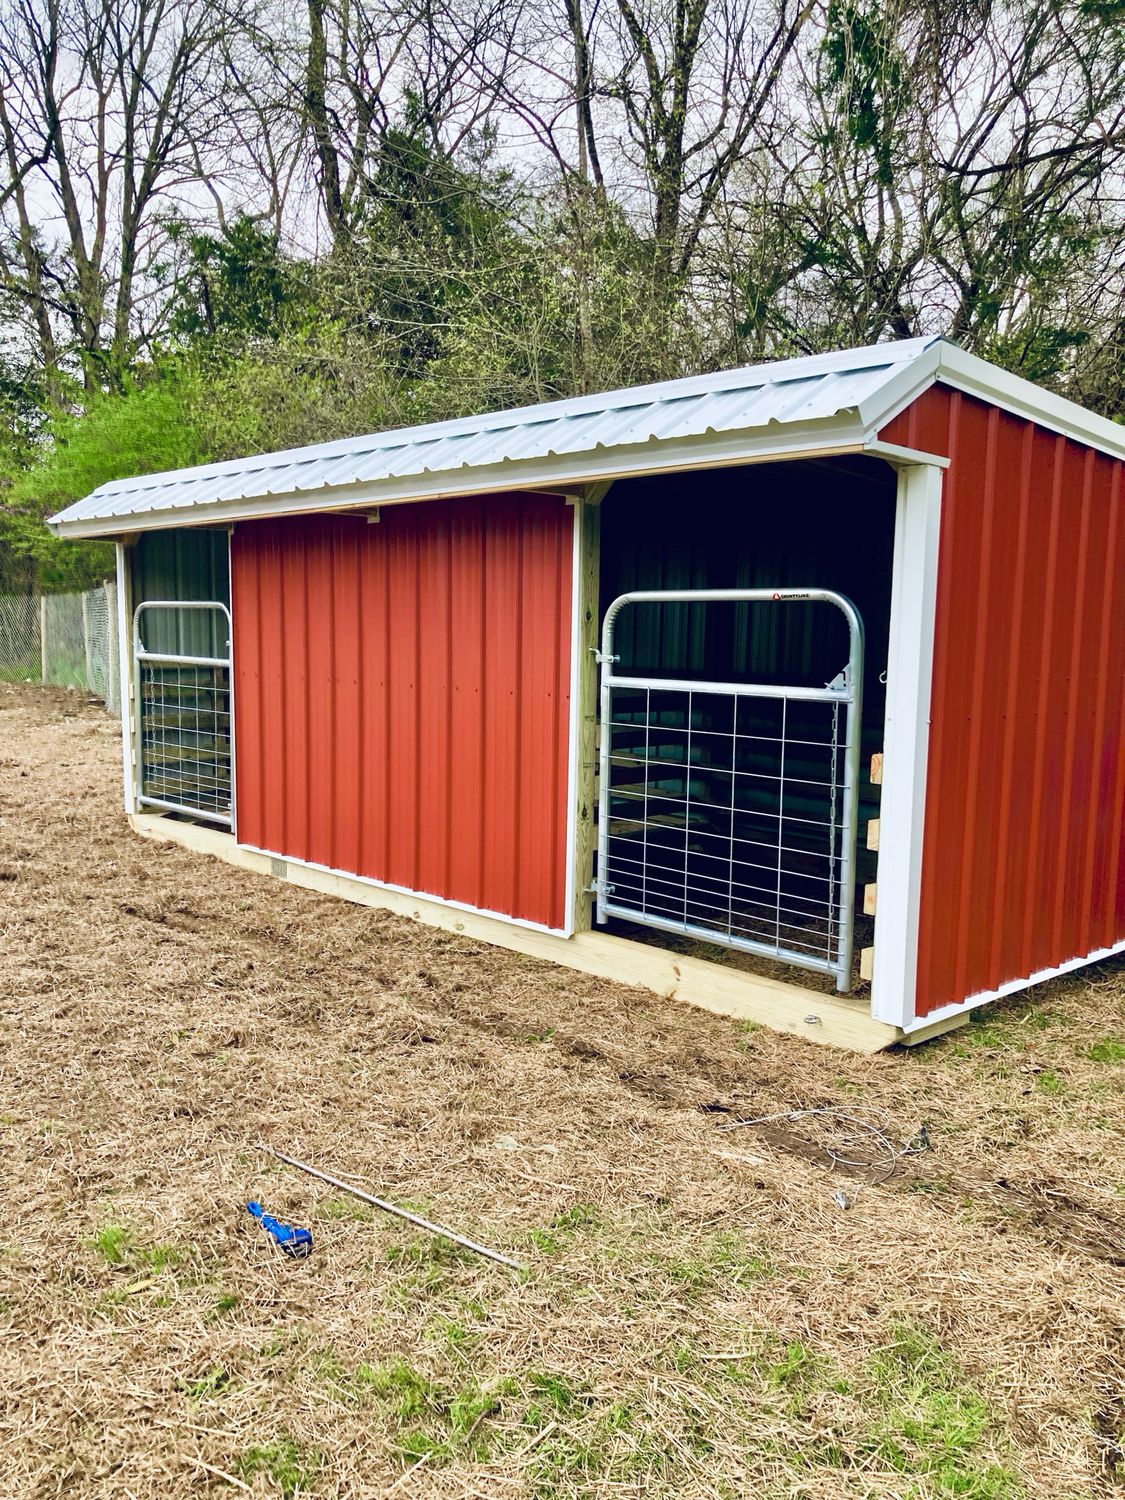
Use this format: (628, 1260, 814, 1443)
(129, 813, 906, 1053)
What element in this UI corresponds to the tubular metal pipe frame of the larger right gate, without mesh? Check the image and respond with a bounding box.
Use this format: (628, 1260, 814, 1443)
(597, 588, 864, 993)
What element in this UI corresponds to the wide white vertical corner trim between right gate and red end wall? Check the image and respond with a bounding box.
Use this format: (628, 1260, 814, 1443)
(872, 465, 942, 1031)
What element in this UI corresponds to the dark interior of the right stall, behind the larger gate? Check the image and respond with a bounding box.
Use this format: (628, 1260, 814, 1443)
(600, 458, 897, 989)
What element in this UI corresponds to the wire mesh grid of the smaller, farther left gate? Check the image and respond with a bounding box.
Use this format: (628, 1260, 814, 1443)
(140, 662, 231, 819)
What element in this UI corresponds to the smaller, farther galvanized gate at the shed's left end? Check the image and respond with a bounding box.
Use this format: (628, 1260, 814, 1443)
(134, 600, 234, 828)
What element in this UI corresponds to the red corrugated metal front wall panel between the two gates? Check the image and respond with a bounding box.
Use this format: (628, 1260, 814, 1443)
(231, 495, 573, 927)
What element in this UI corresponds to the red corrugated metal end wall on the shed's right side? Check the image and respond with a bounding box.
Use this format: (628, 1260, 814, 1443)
(881, 387, 1125, 1016)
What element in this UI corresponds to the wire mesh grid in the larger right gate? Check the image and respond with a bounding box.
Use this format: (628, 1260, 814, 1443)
(606, 689, 845, 968)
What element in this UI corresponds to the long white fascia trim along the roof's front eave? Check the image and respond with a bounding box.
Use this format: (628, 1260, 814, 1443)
(48, 413, 867, 539)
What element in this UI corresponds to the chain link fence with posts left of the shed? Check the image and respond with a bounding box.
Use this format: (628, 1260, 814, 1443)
(0, 584, 122, 714)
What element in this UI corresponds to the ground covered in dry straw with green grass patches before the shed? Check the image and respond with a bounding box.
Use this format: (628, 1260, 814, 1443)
(0, 686, 1125, 1500)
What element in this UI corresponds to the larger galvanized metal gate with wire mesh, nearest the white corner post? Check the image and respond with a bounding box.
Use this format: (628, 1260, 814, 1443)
(597, 588, 863, 990)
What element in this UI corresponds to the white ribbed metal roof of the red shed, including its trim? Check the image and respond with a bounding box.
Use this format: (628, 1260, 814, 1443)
(48, 339, 1125, 537)
